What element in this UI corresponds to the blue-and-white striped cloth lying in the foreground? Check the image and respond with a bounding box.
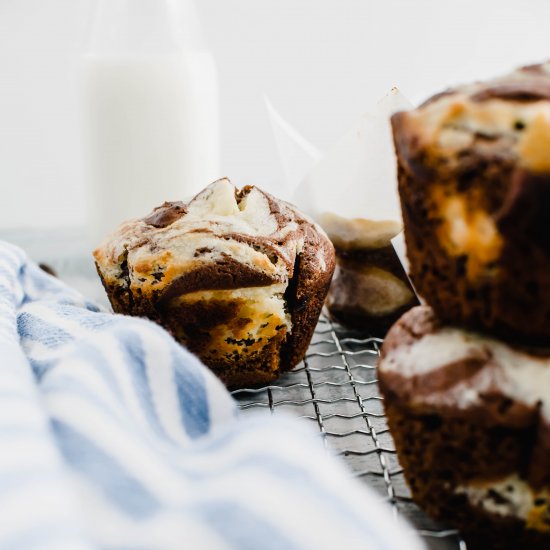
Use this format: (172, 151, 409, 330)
(0, 242, 422, 550)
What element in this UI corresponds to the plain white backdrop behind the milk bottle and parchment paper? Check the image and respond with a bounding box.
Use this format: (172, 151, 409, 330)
(0, 0, 550, 228)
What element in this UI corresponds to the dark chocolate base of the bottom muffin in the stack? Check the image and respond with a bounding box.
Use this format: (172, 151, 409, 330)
(385, 398, 550, 550)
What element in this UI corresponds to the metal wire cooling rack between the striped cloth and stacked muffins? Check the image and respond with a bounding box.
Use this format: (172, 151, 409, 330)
(232, 315, 466, 550)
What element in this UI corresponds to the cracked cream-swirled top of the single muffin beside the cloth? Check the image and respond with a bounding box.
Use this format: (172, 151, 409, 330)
(94, 179, 334, 299)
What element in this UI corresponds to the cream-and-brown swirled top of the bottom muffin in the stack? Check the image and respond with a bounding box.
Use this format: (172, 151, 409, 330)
(379, 306, 550, 427)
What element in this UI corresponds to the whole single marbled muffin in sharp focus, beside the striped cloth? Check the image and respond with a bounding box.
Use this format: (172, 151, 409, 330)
(94, 179, 334, 388)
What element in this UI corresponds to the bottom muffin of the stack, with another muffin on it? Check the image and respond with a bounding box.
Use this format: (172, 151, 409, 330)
(378, 306, 550, 549)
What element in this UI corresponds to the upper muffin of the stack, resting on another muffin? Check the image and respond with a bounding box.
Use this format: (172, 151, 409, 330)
(392, 63, 550, 345)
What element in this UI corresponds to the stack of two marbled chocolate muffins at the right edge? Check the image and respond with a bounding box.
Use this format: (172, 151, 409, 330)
(379, 63, 550, 548)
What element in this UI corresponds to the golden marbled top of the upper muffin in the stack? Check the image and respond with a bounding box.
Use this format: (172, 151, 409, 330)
(393, 62, 550, 172)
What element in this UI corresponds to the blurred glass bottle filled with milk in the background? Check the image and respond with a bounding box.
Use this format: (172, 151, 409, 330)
(82, 0, 220, 244)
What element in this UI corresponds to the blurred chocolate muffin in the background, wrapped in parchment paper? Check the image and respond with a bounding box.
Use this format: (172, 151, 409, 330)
(320, 214, 418, 336)
